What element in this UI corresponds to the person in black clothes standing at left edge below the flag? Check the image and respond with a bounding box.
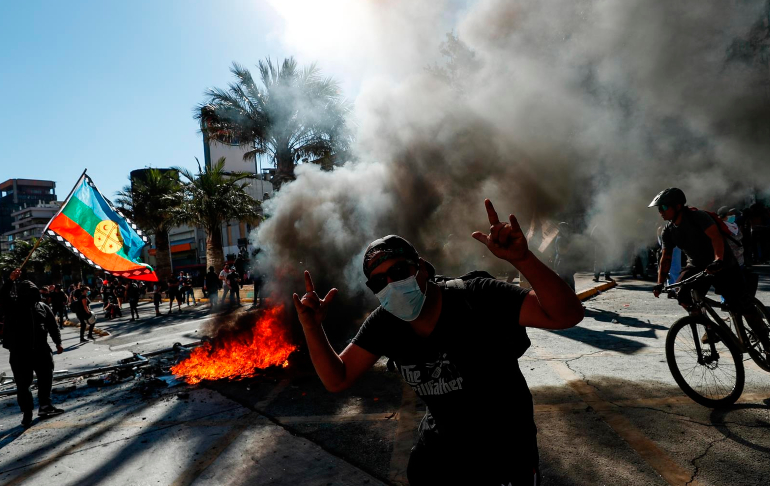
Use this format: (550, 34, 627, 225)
(0, 269, 64, 427)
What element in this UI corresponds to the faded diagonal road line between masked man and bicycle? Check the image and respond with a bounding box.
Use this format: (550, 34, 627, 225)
(548, 361, 699, 486)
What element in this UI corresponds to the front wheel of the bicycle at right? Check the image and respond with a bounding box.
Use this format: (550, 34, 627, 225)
(666, 316, 745, 408)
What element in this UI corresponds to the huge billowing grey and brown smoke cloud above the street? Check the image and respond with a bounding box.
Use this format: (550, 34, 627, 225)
(254, 0, 770, 328)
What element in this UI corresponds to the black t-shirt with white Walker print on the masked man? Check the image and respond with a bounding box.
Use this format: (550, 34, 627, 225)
(352, 278, 537, 469)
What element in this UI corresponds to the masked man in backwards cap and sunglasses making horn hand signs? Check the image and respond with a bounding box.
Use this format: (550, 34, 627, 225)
(294, 200, 583, 486)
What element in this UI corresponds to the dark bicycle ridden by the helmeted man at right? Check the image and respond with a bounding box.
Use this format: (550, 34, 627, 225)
(663, 271, 770, 408)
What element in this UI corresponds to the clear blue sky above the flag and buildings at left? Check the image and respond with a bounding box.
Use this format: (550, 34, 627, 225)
(0, 0, 302, 200)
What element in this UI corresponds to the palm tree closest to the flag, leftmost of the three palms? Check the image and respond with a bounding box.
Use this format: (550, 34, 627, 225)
(116, 169, 182, 282)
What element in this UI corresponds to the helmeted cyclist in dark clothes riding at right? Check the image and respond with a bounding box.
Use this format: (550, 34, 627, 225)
(648, 187, 767, 343)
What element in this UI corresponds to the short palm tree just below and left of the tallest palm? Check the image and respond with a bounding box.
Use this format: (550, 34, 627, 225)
(173, 157, 259, 269)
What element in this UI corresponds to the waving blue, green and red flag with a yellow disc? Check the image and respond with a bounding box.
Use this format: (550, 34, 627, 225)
(43, 172, 158, 282)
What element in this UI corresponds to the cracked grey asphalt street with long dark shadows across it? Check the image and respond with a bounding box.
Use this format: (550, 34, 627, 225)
(0, 267, 770, 486)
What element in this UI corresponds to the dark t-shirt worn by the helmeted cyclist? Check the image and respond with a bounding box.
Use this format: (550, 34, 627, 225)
(661, 208, 736, 268)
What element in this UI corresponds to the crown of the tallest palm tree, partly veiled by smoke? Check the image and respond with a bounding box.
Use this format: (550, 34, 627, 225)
(195, 57, 349, 188)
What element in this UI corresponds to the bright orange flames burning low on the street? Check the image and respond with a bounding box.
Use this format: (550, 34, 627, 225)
(171, 306, 297, 385)
